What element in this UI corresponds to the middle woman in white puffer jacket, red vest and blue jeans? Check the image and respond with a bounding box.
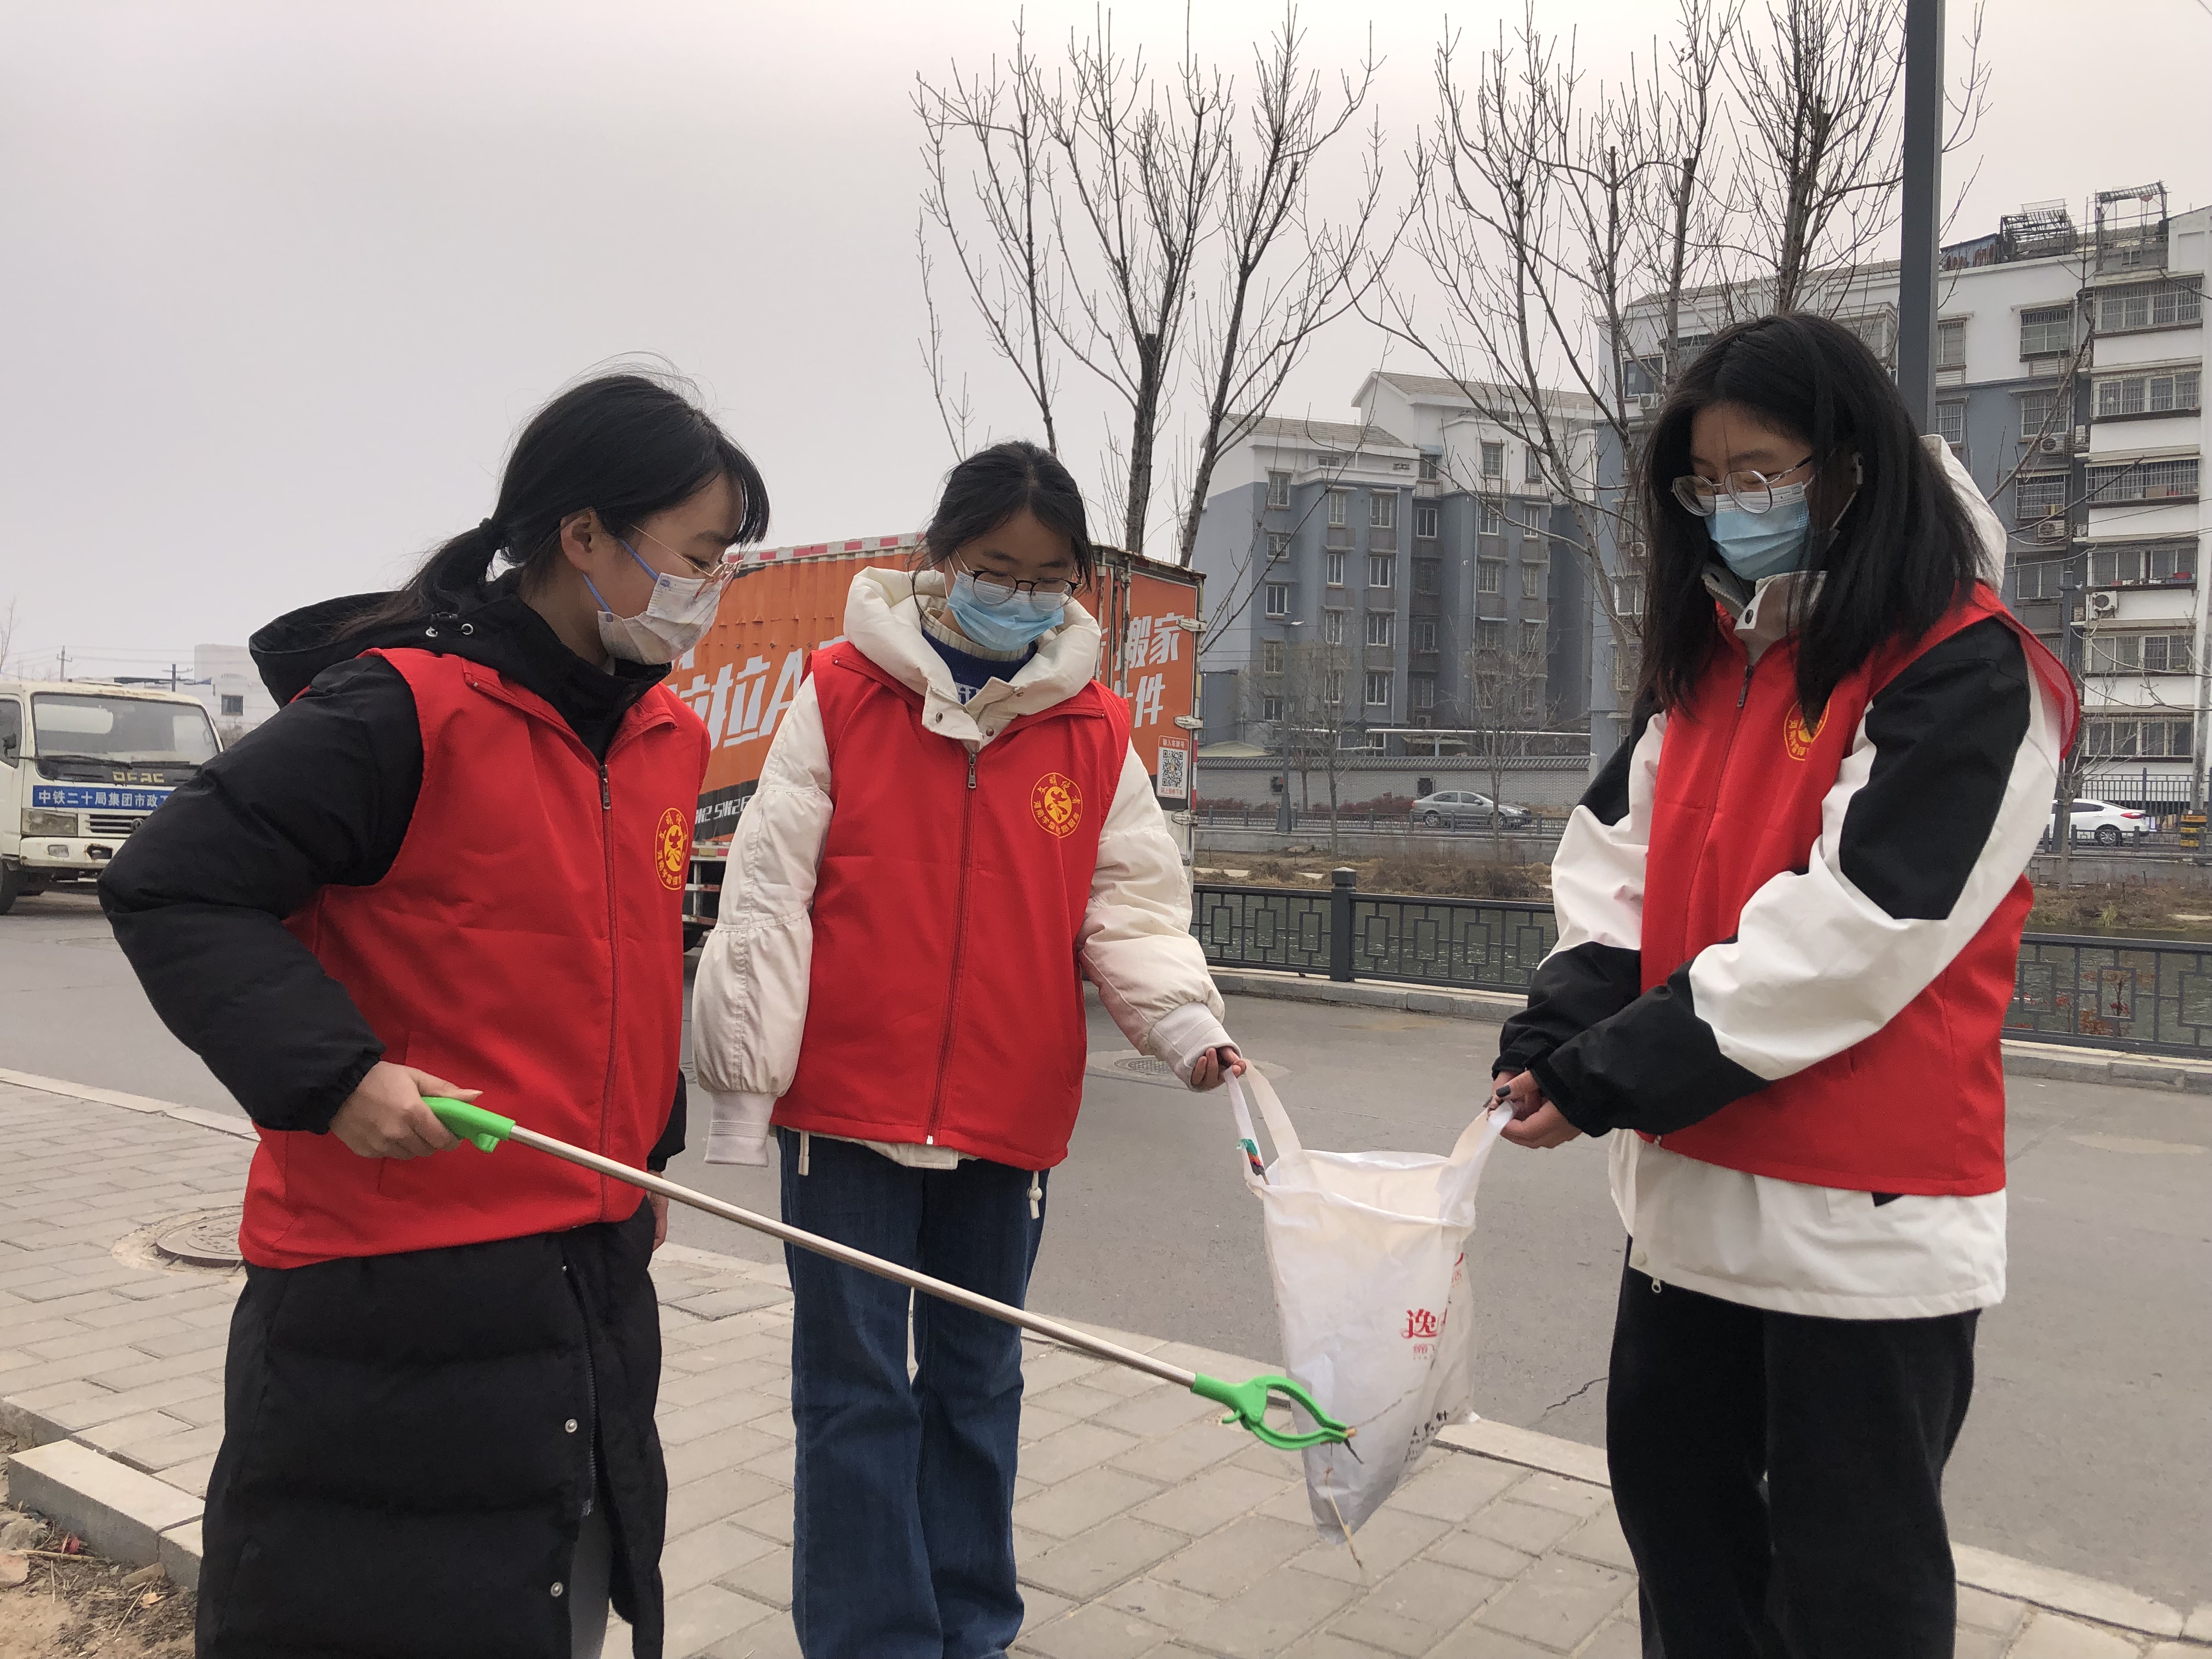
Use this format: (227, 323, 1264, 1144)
(692, 442, 1245, 1659)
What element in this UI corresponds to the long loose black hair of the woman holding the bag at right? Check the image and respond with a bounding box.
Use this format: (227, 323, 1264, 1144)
(1635, 317, 1978, 714)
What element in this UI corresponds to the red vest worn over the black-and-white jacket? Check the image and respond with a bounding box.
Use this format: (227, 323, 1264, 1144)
(1644, 584, 2077, 1194)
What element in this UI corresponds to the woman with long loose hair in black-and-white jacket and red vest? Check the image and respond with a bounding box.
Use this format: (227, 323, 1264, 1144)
(1496, 317, 2077, 1659)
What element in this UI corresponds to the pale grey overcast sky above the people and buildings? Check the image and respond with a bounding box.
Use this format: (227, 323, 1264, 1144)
(0, 0, 2212, 673)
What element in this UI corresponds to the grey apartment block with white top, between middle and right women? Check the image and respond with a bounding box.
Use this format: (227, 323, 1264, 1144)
(1194, 371, 1595, 754)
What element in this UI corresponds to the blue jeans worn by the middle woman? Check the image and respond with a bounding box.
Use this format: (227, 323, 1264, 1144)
(776, 1128, 1044, 1659)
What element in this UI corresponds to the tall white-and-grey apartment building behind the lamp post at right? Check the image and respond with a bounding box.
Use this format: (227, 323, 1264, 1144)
(1593, 184, 2212, 810)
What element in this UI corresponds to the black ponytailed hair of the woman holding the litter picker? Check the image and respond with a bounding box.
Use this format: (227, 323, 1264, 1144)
(356, 371, 768, 628)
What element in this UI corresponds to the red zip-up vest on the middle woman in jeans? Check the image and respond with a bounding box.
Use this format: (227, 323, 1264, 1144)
(774, 644, 1128, 1170)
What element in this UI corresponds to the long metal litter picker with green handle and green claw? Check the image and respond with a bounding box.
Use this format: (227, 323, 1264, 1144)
(422, 1095, 1352, 1451)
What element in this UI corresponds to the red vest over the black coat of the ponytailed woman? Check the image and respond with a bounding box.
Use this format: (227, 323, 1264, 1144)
(254, 650, 706, 1267)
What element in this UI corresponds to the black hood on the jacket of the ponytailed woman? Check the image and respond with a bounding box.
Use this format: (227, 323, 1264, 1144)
(246, 573, 668, 708)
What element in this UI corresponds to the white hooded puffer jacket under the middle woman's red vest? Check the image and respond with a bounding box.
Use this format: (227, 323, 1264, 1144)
(692, 568, 1230, 1164)
